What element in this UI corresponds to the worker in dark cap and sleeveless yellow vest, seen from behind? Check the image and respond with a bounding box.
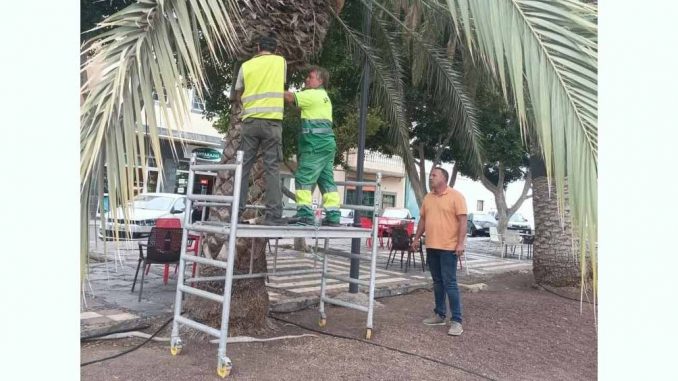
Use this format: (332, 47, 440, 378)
(235, 37, 287, 225)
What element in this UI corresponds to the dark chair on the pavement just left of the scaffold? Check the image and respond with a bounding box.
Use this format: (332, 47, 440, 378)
(132, 227, 182, 301)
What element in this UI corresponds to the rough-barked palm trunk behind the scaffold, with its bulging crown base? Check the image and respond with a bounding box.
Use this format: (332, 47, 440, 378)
(185, 0, 344, 334)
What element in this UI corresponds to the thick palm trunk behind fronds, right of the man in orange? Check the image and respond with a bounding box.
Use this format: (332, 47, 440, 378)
(530, 155, 580, 287)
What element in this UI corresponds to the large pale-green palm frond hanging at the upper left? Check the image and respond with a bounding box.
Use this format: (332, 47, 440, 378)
(80, 0, 240, 280)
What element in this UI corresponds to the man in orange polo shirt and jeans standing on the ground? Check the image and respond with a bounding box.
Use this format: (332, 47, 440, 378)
(412, 167, 467, 336)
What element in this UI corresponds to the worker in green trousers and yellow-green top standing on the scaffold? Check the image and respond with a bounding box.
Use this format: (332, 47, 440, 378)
(285, 66, 341, 226)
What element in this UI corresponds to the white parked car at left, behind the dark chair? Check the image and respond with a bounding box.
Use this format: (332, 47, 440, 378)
(99, 193, 186, 239)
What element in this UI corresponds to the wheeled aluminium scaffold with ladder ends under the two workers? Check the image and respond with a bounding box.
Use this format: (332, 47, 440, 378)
(170, 151, 381, 378)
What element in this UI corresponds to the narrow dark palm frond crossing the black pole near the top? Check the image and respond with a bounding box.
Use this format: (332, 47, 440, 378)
(331, 9, 414, 177)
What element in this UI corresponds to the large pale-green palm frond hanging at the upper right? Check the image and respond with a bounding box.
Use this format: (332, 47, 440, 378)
(447, 0, 598, 294)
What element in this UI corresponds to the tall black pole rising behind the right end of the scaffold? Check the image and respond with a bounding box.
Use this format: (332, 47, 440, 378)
(348, 1, 376, 294)
